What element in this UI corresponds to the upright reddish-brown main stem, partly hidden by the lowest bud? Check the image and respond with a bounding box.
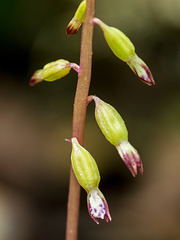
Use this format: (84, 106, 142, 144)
(66, 0, 95, 240)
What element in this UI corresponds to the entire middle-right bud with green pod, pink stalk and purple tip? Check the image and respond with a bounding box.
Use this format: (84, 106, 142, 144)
(88, 96, 143, 177)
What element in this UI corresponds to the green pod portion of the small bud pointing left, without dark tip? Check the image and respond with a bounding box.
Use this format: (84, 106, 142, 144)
(42, 59, 71, 82)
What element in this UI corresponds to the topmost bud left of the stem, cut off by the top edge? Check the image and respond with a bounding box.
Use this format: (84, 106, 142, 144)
(66, 0, 86, 36)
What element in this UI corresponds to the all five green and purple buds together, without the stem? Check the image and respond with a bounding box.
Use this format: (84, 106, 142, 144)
(30, 0, 155, 224)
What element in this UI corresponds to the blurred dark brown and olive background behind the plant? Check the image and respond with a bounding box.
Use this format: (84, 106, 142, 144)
(0, 0, 180, 240)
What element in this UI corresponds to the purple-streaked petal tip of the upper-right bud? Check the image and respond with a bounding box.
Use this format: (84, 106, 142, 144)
(127, 54, 155, 86)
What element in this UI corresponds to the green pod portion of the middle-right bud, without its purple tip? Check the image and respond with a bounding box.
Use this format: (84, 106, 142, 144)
(89, 96, 128, 147)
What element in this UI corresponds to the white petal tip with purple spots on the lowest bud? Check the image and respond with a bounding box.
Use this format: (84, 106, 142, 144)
(87, 188, 112, 224)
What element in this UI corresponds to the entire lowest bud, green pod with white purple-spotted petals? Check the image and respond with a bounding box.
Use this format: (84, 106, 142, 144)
(71, 138, 111, 224)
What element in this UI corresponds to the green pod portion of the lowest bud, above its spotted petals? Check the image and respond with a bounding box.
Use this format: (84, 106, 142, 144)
(71, 138, 100, 192)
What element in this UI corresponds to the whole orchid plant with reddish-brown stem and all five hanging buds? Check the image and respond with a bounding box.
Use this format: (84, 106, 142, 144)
(30, 0, 155, 240)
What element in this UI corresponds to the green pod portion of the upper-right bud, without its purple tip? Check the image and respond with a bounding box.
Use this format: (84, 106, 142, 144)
(93, 18, 135, 62)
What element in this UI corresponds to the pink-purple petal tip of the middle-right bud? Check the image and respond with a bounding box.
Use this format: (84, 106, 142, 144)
(116, 140, 144, 177)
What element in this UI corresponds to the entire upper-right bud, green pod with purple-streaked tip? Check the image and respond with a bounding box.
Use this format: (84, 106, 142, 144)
(92, 18, 155, 86)
